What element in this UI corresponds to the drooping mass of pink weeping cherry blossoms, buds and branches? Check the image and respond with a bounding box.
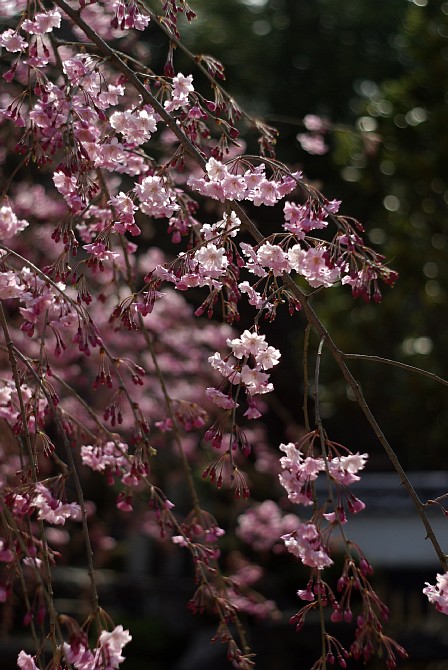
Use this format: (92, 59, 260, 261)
(0, 0, 448, 670)
